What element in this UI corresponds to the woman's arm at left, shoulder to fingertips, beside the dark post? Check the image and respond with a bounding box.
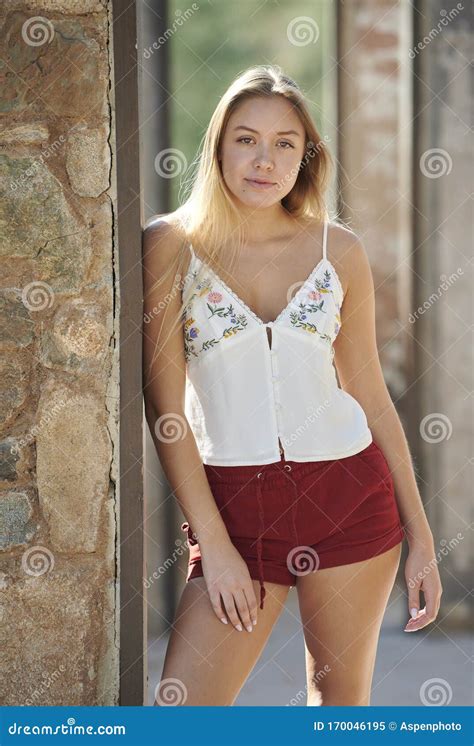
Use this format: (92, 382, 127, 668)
(143, 219, 257, 628)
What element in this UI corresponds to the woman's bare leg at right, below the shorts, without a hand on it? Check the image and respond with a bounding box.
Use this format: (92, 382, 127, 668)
(296, 542, 402, 706)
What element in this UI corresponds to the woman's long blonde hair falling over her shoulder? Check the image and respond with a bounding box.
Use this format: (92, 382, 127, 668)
(146, 65, 333, 372)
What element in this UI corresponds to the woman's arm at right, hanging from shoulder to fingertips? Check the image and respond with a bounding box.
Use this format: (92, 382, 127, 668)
(334, 231, 442, 632)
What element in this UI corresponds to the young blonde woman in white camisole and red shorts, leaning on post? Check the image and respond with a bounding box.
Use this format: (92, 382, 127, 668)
(144, 66, 441, 705)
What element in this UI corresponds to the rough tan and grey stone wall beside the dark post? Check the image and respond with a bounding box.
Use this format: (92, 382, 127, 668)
(0, 0, 119, 705)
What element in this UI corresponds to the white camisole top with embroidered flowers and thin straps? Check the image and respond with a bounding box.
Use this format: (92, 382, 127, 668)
(182, 222, 372, 466)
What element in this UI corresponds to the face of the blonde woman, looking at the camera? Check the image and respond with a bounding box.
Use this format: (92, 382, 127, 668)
(220, 96, 306, 208)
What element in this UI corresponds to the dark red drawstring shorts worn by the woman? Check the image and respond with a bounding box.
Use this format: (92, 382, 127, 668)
(181, 441, 404, 609)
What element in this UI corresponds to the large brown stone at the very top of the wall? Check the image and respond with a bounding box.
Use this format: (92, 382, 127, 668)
(0, 10, 109, 120)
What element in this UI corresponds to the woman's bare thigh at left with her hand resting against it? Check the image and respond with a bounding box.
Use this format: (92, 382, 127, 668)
(155, 577, 289, 706)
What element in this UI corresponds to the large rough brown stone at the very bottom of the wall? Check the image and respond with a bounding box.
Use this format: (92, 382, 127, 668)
(0, 560, 119, 706)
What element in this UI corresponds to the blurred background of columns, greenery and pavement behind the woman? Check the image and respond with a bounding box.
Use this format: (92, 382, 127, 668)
(137, 0, 473, 706)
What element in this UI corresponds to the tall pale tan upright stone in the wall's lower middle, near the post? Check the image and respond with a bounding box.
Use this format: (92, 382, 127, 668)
(36, 380, 112, 552)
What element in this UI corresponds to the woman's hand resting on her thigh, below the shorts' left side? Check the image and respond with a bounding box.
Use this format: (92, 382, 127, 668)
(201, 540, 257, 632)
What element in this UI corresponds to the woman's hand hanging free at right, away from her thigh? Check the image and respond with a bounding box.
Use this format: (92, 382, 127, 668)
(404, 536, 443, 632)
